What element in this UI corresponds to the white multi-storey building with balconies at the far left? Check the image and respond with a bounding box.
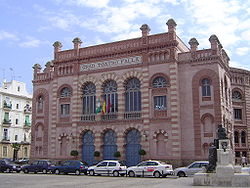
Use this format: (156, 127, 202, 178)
(0, 80, 32, 158)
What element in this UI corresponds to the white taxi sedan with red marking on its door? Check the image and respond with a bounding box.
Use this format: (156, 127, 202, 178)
(127, 160, 174, 177)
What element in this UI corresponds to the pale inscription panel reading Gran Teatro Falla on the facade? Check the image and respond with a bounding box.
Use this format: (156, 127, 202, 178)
(80, 56, 142, 72)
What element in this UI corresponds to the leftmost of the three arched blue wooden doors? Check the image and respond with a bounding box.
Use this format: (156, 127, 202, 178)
(82, 131, 95, 165)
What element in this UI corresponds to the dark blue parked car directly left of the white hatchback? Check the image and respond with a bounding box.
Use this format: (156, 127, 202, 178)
(51, 160, 88, 175)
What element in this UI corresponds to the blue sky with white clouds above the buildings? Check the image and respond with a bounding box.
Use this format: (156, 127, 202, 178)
(0, 0, 250, 92)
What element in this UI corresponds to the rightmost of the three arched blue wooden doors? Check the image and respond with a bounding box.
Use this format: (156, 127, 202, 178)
(126, 129, 141, 166)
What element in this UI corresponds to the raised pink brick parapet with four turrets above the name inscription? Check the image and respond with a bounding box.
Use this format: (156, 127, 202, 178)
(53, 19, 184, 63)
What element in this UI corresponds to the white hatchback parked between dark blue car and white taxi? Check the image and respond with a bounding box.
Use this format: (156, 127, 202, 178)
(88, 160, 127, 176)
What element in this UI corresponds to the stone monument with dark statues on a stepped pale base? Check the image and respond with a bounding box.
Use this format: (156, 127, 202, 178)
(193, 125, 250, 187)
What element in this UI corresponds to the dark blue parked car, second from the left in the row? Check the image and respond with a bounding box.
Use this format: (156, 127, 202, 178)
(22, 160, 53, 174)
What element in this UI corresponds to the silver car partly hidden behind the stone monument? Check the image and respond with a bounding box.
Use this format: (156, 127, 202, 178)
(174, 161, 208, 177)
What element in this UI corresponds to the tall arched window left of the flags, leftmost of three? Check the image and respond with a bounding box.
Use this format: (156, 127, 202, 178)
(83, 83, 96, 114)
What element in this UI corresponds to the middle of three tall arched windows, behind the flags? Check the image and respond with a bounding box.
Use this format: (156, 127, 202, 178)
(103, 80, 118, 113)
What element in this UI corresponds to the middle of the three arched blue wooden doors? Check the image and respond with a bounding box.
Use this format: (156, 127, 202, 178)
(103, 130, 117, 160)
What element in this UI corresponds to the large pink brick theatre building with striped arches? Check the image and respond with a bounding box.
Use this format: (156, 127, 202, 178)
(31, 19, 250, 165)
